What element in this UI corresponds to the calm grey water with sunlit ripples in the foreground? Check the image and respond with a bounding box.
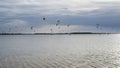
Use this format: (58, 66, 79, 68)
(0, 34, 120, 68)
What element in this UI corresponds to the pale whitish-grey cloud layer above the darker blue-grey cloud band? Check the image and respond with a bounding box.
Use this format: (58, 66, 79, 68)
(0, 0, 120, 17)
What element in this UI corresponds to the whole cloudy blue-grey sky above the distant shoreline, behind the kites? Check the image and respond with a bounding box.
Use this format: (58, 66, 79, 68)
(0, 0, 120, 33)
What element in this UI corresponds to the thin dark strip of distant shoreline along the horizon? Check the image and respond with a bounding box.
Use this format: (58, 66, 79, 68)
(0, 32, 113, 35)
